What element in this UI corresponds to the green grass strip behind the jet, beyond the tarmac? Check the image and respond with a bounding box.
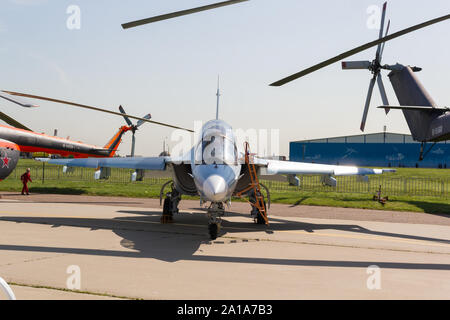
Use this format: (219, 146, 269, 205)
(0, 160, 450, 214)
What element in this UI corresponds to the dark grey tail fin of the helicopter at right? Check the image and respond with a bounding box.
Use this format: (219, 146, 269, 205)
(389, 66, 440, 141)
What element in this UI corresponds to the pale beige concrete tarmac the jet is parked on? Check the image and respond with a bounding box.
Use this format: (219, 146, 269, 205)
(0, 194, 450, 300)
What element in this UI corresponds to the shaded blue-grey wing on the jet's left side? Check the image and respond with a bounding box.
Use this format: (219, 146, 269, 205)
(36, 157, 171, 171)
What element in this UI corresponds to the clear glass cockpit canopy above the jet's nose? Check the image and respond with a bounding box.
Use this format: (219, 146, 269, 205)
(195, 120, 238, 165)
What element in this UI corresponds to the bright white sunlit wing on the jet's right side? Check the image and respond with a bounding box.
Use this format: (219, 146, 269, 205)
(254, 158, 395, 176)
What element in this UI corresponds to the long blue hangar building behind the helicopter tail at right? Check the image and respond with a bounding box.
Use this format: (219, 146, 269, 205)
(289, 132, 450, 168)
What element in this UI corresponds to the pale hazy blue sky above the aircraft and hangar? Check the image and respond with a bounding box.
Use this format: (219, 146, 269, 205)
(0, 0, 450, 155)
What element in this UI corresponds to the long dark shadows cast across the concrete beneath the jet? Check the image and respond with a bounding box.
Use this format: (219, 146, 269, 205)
(0, 210, 450, 270)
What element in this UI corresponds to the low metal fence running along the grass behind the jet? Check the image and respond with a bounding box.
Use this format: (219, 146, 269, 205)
(8, 164, 450, 199)
